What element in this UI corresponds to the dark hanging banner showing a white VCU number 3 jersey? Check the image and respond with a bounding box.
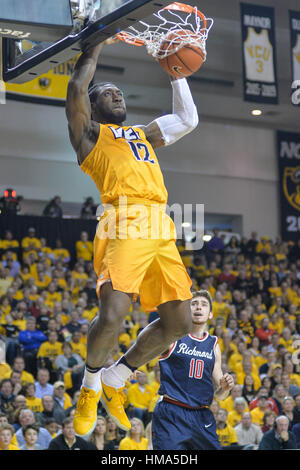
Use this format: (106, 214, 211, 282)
(241, 3, 278, 104)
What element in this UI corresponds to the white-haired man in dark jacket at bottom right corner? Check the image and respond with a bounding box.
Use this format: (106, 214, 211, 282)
(259, 415, 298, 450)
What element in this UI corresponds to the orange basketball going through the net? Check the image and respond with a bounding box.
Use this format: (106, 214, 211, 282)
(159, 30, 205, 78)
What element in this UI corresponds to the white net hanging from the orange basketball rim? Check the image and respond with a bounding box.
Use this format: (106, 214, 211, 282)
(117, 2, 213, 60)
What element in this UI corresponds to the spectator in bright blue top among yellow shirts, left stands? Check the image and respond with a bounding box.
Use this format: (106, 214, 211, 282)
(19, 317, 47, 375)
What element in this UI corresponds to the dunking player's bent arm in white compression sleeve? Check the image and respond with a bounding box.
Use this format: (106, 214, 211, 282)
(144, 76, 199, 148)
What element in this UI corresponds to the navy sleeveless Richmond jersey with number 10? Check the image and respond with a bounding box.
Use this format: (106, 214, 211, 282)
(158, 332, 218, 407)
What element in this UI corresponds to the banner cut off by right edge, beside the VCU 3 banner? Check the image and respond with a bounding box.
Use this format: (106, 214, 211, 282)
(289, 10, 300, 106)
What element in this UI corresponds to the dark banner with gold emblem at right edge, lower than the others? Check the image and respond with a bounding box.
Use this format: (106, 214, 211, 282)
(277, 131, 300, 241)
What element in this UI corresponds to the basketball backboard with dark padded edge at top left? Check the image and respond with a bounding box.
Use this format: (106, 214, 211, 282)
(0, 0, 170, 83)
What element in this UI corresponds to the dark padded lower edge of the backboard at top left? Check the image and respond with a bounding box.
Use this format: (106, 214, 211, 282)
(2, 0, 170, 83)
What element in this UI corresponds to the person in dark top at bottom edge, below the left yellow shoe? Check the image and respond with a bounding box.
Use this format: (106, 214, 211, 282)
(48, 418, 97, 450)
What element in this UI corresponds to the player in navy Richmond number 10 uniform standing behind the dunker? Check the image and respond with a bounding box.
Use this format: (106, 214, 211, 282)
(152, 290, 234, 450)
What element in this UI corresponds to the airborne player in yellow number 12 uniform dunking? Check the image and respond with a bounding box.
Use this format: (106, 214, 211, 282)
(66, 39, 198, 436)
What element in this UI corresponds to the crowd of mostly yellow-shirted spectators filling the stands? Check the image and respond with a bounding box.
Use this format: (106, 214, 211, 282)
(0, 227, 300, 450)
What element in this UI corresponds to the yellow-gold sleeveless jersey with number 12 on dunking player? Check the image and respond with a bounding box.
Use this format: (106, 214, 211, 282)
(80, 124, 168, 204)
